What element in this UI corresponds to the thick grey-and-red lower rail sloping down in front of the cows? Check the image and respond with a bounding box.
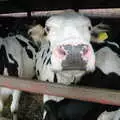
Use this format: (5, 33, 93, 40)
(0, 76, 120, 106)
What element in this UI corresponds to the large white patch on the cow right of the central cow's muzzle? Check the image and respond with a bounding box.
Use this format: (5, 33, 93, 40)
(96, 47, 120, 75)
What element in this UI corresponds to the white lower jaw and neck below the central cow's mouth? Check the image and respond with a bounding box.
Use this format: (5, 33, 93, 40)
(43, 70, 85, 103)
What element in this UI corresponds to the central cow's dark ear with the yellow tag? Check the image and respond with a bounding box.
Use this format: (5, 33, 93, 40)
(91, 23, 109, 43)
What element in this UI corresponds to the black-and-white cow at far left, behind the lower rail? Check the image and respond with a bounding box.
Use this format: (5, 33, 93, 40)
(0, 35, 37, 119)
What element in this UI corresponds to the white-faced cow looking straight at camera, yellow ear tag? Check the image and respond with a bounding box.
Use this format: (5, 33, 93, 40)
(28, 12, 109, 119)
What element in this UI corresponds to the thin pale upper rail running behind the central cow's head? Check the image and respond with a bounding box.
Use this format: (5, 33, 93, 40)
(0, 8, 120, 18)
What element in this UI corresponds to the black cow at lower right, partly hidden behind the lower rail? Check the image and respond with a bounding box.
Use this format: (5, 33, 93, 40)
(43, 68, 120, 120)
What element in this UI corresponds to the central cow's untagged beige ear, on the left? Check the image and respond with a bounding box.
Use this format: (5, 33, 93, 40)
(28, 24, 44, 42)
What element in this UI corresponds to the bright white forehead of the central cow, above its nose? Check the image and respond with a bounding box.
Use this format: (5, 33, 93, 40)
(46, 12, 91, 50)
